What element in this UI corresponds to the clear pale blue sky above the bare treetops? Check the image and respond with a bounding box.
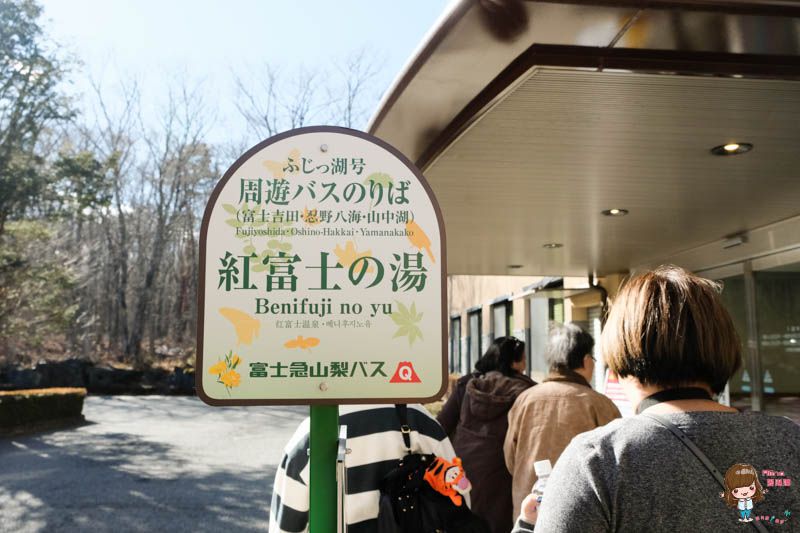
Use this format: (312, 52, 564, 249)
(40, 0, 448, 142)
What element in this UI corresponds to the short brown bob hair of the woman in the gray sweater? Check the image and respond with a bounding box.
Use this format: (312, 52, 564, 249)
(601, 265, 742, 393)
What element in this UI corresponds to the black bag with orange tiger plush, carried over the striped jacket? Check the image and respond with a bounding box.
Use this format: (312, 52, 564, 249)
(378, 405, 491, 533)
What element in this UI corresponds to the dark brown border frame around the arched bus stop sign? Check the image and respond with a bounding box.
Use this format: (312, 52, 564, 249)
(195, 126, 449, 407)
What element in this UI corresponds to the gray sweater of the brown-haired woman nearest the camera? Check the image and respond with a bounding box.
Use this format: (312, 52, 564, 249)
(514, 412, 800, 533)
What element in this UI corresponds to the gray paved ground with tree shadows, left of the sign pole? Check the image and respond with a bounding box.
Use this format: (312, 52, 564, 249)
(0, 396, 308, 533)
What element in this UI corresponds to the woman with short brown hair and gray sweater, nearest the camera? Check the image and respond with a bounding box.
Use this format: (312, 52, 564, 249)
(514, 266, 800, 533)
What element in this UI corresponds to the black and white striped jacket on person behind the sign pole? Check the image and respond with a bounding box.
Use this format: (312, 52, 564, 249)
(269, 404, 456, 533)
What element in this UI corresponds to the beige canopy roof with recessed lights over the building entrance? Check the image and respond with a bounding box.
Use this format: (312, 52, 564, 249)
(370, 1, 800, 276)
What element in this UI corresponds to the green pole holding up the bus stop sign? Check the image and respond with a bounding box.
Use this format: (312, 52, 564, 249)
(309, 405, 339, 533)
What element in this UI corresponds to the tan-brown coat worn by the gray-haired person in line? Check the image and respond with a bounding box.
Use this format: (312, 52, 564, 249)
(503, 374, 620, 516)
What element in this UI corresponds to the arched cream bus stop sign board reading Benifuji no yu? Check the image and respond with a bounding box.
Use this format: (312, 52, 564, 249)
(197, 127, 447, 405)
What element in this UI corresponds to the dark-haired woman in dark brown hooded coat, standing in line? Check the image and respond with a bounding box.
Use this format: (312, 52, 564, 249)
(437, 337, 536, 533)
